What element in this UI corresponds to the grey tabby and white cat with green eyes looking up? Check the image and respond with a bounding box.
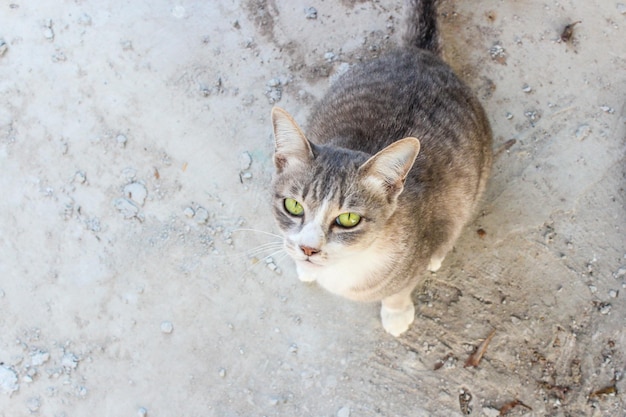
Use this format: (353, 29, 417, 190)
(271, 0, 493, 336)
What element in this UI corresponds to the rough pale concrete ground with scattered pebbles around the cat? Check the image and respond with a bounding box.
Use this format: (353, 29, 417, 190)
(0, 0, 626, 417)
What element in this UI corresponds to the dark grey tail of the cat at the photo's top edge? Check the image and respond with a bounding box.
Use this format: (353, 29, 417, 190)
(402, 0, 440, 55)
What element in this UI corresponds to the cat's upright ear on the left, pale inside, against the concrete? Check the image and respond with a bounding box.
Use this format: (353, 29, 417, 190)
(272, 107, 313, 173)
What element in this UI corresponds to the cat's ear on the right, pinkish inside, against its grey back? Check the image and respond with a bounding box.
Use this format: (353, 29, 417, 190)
(359, 137, 420, 201)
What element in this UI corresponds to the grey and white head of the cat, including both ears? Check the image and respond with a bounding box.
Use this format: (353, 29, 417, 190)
(272, 108, 419, 265)
